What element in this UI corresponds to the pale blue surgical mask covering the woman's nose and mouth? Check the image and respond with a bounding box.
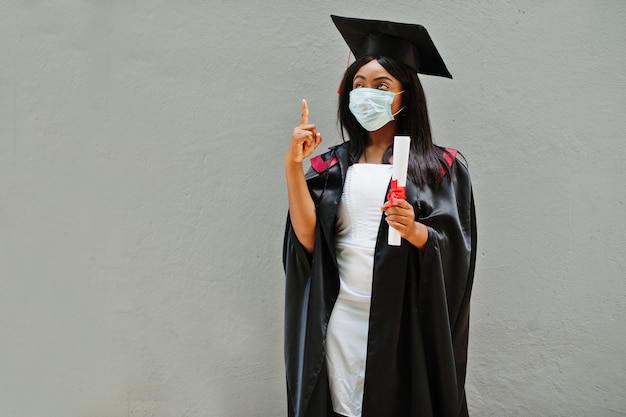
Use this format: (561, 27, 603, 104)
(348, 88, 404, 132)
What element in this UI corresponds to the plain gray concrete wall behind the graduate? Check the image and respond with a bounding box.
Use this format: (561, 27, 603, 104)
(0, 0, 626, 417)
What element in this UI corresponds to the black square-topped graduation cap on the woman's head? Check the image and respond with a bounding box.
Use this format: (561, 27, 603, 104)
(330, 15, 452, 78)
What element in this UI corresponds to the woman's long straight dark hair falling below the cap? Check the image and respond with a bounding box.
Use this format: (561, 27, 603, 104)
(337, 56, 447, 185)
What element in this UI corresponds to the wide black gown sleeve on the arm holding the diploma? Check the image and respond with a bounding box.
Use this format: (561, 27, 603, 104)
(418, 160, 476, 415)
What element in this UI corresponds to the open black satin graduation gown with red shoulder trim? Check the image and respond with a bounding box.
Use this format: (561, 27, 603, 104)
(283, 141, 476, 417)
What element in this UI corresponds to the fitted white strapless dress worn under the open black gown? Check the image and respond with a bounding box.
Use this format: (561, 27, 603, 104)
(326, 164, 392, 417)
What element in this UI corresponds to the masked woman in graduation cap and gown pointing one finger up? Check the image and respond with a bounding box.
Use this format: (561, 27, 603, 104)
(283, 16, 476, 417)
